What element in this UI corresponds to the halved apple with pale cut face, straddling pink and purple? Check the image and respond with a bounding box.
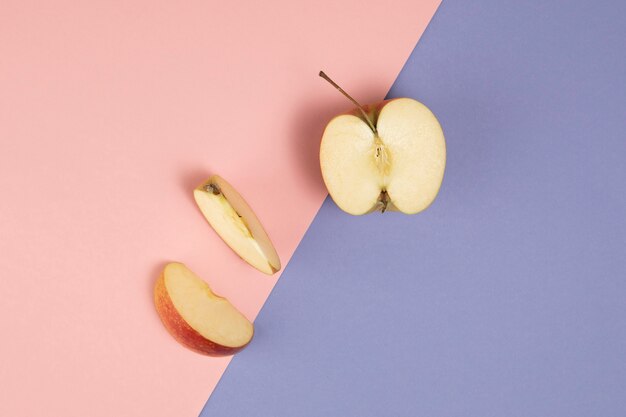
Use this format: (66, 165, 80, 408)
(320, 98, 446, 215)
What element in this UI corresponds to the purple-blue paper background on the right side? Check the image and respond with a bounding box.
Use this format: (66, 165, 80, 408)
(202, 0, 626, 417)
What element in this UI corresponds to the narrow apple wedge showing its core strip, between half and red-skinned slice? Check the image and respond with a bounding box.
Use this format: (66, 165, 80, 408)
(193, 175, 280, 275)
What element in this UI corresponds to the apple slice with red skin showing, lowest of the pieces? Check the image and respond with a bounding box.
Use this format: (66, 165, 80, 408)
(154, 262, 254, 356)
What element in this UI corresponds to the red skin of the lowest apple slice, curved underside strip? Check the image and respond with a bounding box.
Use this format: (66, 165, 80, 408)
(154, 274, 252, 356)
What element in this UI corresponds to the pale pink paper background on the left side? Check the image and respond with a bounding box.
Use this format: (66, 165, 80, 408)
(0, 0, 439, 417)
